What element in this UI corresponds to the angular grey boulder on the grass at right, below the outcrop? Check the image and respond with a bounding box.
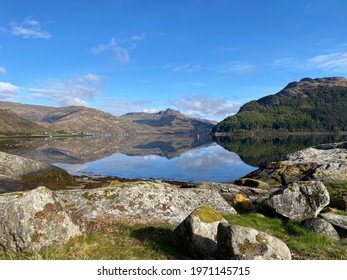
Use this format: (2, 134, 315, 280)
(265, 181, 330, 220)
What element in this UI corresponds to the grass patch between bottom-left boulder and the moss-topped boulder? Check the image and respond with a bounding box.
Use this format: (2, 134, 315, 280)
(0, 224, 185, 260)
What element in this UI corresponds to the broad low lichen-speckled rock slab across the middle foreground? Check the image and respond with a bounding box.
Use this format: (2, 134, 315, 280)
(57, 181, 236, 225)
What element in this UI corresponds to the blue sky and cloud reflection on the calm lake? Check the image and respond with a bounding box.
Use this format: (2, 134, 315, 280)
(56, 145, 255, 182)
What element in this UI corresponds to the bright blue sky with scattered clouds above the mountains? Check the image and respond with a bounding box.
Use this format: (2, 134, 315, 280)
(0, 0, 347, 120)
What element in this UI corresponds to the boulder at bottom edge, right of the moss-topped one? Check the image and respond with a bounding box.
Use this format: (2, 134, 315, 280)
(217, 223, 291, 260)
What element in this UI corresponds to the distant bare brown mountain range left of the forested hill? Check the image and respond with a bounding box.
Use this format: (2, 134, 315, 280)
(0, 102, 215, 135)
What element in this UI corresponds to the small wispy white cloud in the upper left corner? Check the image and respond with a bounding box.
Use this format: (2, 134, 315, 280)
(10, 18, 52, 39)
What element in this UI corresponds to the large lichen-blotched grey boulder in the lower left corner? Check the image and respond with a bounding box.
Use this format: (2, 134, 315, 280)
(0, 187, 83, 253)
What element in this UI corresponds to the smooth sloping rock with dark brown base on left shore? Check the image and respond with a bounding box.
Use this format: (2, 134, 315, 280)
(0, 152, 76, 193)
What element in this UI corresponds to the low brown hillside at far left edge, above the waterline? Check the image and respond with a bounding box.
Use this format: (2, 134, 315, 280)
(0, 109, 47, 136)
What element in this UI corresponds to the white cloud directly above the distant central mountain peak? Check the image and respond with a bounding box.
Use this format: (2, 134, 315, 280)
(171, 94, 242, 120)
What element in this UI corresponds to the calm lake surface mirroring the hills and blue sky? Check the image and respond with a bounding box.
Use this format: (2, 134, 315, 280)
(0, 135, 346, 182)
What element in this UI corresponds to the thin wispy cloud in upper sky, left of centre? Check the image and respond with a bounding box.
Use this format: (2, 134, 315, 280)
(92, 33, 147, 64)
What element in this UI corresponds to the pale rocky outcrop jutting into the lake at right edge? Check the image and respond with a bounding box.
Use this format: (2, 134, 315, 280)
(246, 142, 347, 186)
